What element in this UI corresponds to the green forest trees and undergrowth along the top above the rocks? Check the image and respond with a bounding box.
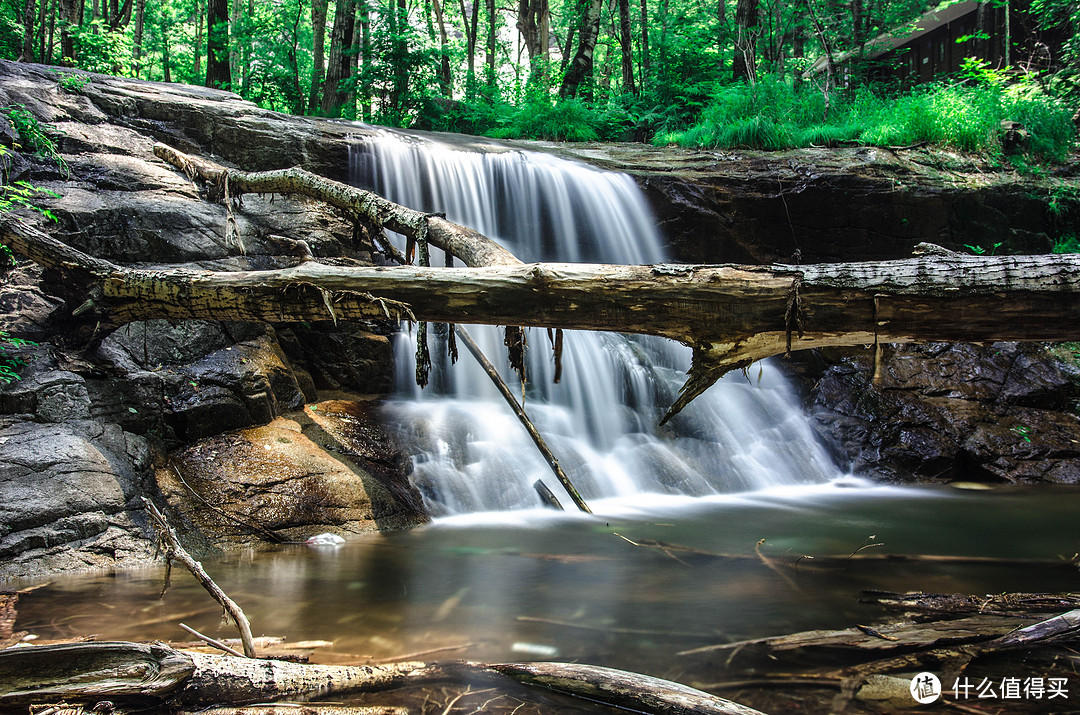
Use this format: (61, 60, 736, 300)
(0, 0, 1080, 154)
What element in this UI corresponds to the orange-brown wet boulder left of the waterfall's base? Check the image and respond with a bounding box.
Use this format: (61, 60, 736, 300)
(158, 401, 426, 548)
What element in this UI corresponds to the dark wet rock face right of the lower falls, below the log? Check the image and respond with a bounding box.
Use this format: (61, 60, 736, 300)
(785, 343, 1080, 484)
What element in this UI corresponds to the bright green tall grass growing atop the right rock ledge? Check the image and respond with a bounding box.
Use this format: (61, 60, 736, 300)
(653, 78, 1076, 161)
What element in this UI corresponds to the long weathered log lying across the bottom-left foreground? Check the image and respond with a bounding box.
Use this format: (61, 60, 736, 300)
(0, 643, 757, 715)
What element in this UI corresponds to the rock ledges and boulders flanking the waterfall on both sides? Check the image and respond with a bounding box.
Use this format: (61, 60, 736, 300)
(0, 58, 1080, 579)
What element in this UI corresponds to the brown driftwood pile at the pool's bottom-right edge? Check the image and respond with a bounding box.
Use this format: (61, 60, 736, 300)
(679, 592, 1080, 712)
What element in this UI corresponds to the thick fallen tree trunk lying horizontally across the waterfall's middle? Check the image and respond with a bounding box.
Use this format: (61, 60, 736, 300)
(0, 217, 1080, 417)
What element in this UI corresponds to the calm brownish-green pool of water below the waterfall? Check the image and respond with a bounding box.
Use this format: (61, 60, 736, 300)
(8, 480, 1080, 712)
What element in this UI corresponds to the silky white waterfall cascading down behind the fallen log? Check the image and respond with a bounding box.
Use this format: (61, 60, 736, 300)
(350, 131, 839, 514)
